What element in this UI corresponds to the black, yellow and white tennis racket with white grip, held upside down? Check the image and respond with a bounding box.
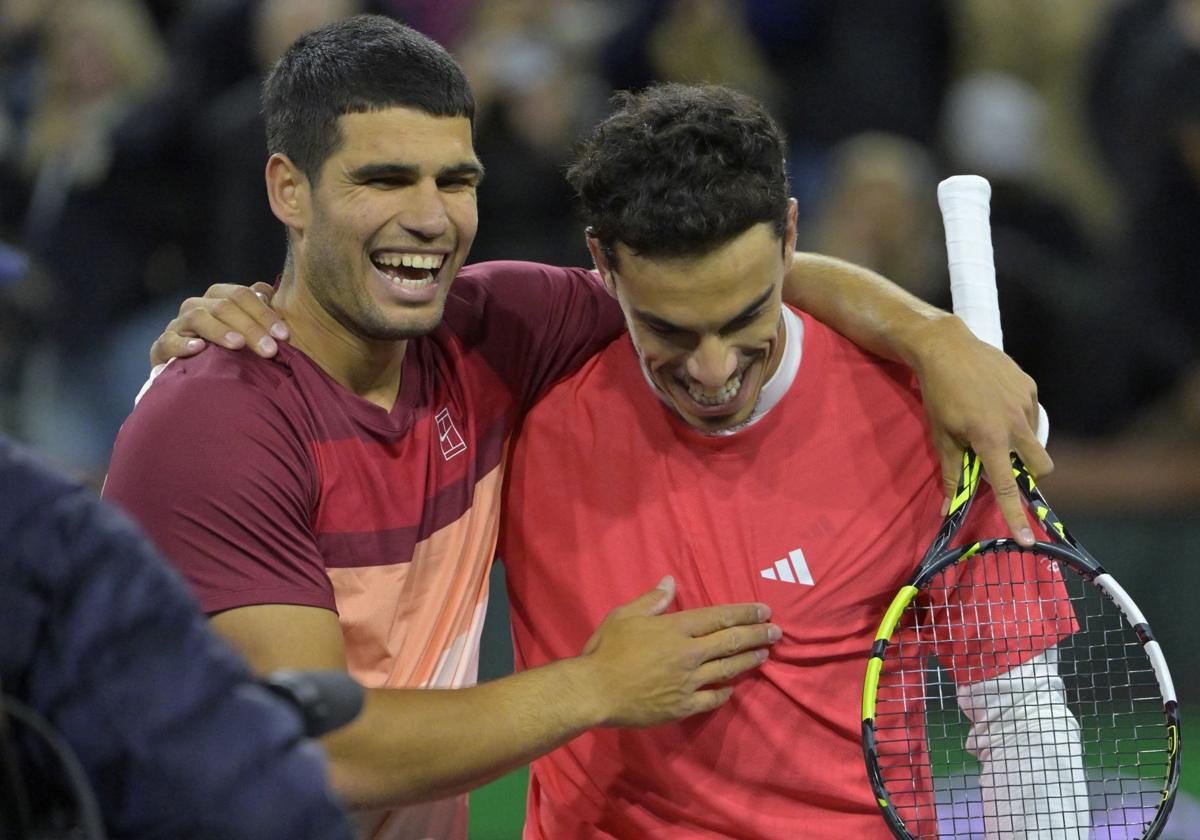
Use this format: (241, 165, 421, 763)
(863, 176, 1180, 840)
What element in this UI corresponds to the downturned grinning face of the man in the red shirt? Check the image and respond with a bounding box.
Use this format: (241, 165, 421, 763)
(592, 210, 796, 433)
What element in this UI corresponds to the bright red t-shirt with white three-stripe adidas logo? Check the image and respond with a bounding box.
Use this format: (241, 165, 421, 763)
(500, 309, 1070, 840)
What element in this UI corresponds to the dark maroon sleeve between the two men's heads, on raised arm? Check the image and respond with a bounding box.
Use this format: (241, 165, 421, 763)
(448, 262, 625, 410)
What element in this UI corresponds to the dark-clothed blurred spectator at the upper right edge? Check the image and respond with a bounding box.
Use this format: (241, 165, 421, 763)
(1088, 0, 1200, 420)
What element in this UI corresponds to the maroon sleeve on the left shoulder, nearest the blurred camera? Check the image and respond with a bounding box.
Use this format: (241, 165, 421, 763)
(103, 360, 336, 613)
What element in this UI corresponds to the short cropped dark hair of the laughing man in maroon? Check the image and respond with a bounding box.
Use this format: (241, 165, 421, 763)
(263, 14, 475, 182)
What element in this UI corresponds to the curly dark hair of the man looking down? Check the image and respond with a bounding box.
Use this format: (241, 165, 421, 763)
(566, 84, 788, 263)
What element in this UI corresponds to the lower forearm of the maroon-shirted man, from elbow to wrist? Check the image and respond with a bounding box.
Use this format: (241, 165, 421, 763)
(323, 659, 605, 809)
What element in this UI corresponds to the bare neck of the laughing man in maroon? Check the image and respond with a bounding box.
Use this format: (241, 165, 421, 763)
(271, 269, 408, 410)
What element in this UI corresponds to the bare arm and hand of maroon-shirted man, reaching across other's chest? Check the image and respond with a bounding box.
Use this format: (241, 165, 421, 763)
(212, 588, 780, 809)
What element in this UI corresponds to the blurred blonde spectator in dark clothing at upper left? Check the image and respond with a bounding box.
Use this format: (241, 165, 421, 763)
(17, 0, 167, 314)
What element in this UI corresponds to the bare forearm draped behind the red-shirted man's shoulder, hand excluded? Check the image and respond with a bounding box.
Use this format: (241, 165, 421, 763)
(784, 252, 966, 370)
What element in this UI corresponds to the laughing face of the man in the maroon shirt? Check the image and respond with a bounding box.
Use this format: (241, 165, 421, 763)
(280, 108, 482, 341)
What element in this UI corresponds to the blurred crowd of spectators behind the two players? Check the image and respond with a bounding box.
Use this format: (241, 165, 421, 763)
(0, 0, 1200, 825)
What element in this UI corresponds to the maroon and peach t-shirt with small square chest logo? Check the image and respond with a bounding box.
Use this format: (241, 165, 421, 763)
(104, 263, 622, 839)
